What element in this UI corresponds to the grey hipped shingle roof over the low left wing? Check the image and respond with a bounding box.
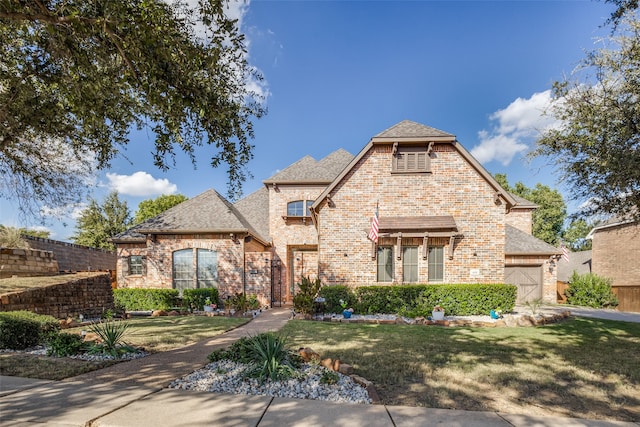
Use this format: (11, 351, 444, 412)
(113, 190, 262, 242)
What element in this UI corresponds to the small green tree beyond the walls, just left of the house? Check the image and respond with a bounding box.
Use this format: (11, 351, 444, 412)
(72, 191, 131, 250)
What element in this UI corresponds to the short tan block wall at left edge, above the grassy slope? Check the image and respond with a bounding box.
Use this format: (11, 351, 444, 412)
(0, 248, 59, 279)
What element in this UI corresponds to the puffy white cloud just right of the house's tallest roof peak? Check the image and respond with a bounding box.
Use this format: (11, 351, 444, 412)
(471, 90, 557, 166)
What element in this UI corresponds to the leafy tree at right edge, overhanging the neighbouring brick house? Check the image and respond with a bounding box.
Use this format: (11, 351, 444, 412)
(533, 12, 640, 222)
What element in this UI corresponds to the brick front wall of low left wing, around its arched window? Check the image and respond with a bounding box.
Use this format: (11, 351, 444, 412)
(117, 234, 271, 305)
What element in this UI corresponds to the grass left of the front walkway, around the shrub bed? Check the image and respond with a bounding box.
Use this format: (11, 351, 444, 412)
(0, 316, 249, 380)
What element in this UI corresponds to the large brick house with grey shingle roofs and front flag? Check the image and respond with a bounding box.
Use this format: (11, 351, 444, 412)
(114, 121, 560, 305)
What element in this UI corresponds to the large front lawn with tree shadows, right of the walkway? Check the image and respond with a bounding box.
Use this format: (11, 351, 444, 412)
(281, 319, 640, 421)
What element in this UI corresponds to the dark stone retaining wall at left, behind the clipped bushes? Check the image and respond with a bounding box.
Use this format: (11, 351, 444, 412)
(0, 274, 114, 319)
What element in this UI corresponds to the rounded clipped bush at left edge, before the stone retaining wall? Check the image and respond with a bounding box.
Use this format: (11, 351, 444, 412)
(0, 311, 60, 350)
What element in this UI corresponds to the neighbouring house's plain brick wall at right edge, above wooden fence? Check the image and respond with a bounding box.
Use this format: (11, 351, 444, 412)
(591, 223, 640, 287)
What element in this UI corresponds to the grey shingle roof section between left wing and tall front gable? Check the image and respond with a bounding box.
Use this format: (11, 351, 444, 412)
(263, 149, 353, 184)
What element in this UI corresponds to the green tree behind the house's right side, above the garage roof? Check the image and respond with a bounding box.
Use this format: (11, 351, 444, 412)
(495, 174, 567, 246)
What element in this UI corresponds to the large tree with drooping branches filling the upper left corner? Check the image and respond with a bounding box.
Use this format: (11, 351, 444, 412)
(0, 0, 265, 219)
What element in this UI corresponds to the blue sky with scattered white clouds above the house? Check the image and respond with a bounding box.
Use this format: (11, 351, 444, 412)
(0, 0, 613, 241)
